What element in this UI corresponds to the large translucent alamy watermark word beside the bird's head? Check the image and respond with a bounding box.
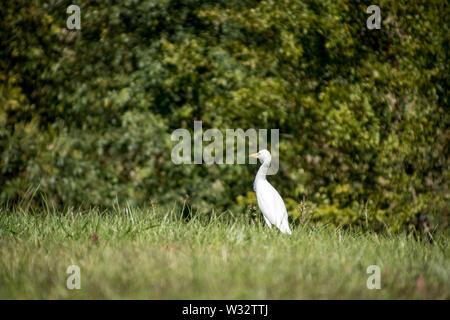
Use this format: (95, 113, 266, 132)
(171, 121, 279, 175)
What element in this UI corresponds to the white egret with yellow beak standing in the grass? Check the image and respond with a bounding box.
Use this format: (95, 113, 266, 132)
(250, 149, 292, 234)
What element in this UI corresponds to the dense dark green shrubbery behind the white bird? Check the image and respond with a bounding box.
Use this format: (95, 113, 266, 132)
(0, 0, 450, 230)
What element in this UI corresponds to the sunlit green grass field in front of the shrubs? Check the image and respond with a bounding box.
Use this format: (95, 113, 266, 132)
(0, 208, 450, 299)
